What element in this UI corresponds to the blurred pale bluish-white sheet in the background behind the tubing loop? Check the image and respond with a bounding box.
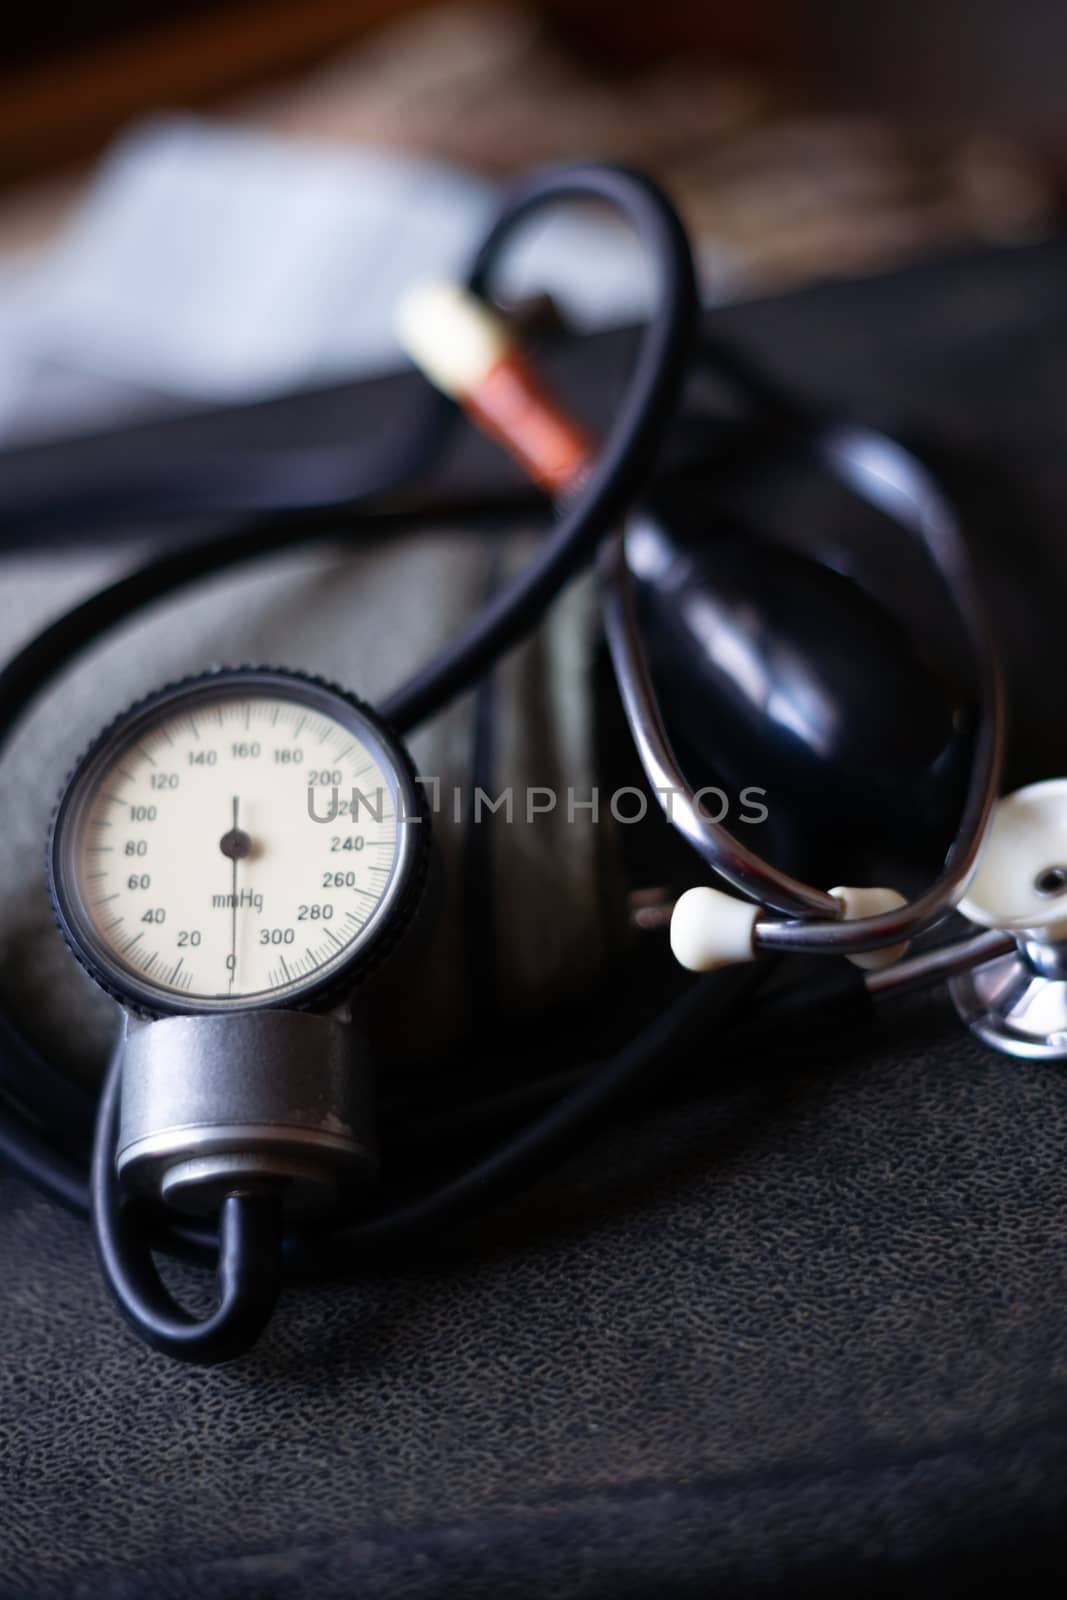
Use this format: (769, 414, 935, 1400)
(0, 117, 668, 442)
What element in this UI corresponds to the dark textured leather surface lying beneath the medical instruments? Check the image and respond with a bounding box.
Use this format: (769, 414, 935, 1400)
(0, 233, 1067, 1600)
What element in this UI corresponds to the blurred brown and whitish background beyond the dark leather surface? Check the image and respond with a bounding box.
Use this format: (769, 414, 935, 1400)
(0, 0, 1067, 446)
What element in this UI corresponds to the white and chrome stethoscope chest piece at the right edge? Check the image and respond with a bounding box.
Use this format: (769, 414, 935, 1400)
(949, 778, 1067, 1061)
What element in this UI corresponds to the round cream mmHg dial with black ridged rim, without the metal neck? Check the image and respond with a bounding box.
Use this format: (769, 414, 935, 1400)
(48, 667, 429, 1016)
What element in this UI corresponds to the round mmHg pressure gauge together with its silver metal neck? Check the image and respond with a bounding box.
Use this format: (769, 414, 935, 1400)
(48, 667, 429, 1213)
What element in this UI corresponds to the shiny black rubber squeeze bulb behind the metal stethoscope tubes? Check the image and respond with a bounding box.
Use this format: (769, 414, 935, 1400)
(627, 507, 960, 883)
